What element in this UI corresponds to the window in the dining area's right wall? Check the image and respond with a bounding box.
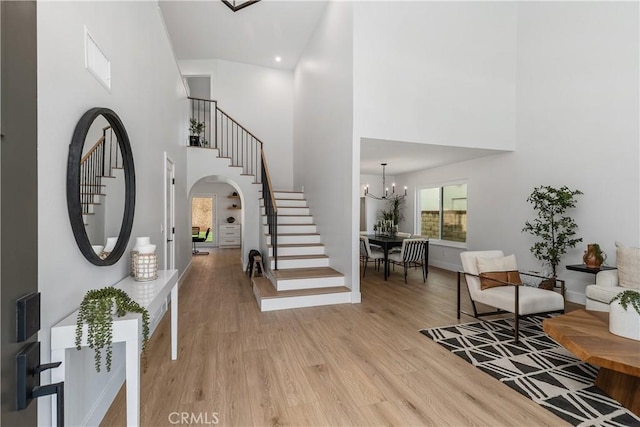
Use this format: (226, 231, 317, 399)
(418, 184, 467, 243)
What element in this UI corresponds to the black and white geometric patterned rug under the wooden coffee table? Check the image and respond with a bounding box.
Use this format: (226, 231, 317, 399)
(420, 316, 640, 427)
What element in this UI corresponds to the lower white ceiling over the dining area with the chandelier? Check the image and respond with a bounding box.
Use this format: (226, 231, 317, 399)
(360, 138, 505, 175)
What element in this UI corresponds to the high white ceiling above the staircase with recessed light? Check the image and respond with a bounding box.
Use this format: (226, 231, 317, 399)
(159, 0, 327, 70)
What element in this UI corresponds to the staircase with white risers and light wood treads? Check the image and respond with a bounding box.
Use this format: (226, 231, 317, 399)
(253, 191, 351, 311)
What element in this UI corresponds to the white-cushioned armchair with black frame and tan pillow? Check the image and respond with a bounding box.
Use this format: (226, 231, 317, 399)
(457, 251, 564, 342)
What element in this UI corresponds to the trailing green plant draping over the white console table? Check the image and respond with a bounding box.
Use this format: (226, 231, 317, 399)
(76, 287, 149, 372)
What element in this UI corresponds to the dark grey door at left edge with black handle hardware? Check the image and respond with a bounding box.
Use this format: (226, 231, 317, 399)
(0, 1, 38, 426)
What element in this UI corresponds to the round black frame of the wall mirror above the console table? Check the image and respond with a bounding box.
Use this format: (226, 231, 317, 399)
(67, 107, 136, 266)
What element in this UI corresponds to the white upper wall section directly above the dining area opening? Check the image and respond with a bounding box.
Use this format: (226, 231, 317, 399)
(353, 1, 517, 149)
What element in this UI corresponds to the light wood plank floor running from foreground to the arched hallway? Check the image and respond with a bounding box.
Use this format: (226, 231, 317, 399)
(103, 249, 576, 426)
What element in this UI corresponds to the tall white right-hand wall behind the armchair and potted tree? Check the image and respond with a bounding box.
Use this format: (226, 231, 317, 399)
(397, 2, 640, 303)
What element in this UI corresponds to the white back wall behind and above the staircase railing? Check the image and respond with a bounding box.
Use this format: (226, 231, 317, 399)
(179, 59, 293, 190)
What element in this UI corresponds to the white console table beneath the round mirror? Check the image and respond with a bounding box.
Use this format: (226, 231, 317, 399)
(51, 270, 178, 426)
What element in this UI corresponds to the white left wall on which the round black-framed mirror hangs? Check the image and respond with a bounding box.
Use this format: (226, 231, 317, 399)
(37, 2, 191, 425)
